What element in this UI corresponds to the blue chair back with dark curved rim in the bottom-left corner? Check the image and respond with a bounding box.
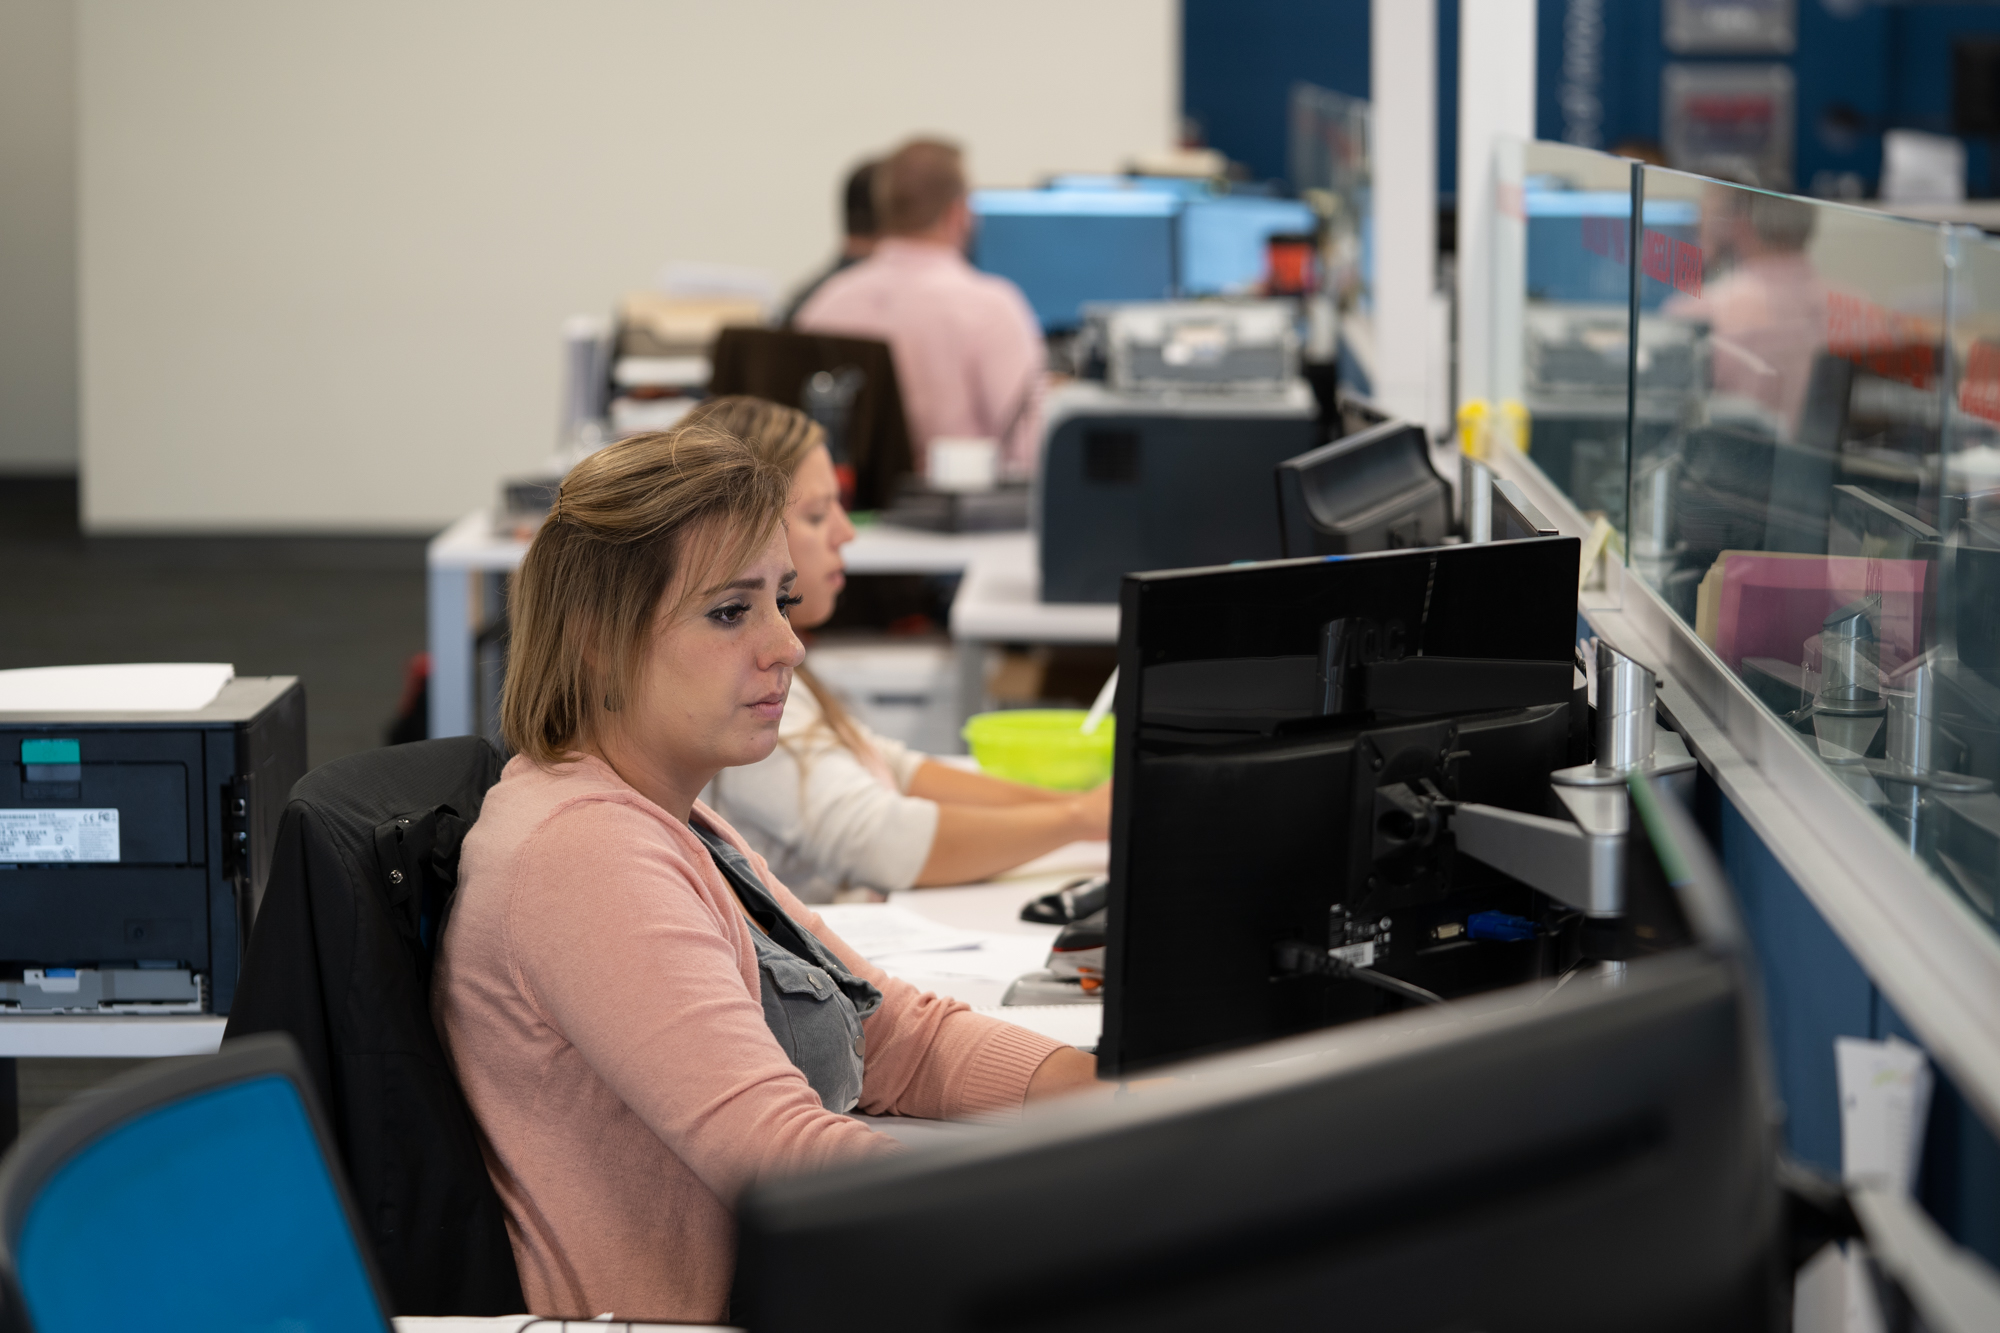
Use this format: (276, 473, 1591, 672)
(0, 1035, 390, 1333)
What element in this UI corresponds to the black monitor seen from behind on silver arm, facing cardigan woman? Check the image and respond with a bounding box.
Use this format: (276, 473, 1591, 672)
(1098, 538, 1588, 1075)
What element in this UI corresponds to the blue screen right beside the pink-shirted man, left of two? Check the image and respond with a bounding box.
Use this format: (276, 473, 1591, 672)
(972, 190, 1182, 332)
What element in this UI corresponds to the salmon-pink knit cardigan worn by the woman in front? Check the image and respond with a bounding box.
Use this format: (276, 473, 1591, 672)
(432, 759, 1058, 1321)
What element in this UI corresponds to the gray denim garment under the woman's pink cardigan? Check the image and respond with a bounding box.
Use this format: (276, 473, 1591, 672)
(688, 823, 882, 1113)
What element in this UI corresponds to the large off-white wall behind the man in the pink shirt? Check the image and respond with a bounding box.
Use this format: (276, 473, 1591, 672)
(78, 0, 1180, 532)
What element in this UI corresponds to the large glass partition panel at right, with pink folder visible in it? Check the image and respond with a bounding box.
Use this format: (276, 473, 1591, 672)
(1628, 168, 2000, 919)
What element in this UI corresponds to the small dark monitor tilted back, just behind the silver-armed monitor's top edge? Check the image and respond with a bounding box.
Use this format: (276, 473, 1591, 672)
(1278, 420, 1452, 556)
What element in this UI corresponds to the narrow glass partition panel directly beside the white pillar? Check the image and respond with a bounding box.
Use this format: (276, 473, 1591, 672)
(1490, 142, 1632, 532)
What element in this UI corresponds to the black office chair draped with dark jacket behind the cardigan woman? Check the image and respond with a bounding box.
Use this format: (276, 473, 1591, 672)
(228, 737, 526, 1315)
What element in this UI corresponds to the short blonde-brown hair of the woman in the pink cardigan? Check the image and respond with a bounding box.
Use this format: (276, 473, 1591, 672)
(500, 424, 792, 765)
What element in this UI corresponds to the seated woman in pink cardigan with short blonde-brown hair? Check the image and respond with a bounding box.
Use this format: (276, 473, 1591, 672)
(432, 426, 1096, 1321)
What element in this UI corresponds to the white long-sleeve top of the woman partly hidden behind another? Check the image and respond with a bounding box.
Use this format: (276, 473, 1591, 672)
(704, 683, 938, 903)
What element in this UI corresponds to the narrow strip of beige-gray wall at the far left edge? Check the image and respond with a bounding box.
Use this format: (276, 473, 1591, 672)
(0, 0, 76, 474)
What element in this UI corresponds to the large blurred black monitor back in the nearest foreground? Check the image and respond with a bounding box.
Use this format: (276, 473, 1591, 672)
(730, 780, 1790, 1333)
